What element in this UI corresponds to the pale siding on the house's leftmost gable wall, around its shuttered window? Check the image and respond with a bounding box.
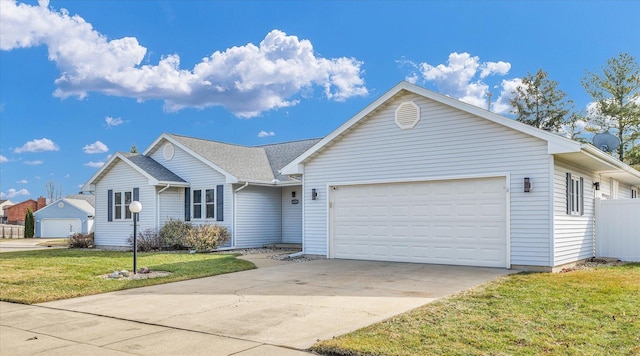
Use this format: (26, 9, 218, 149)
(94, 161, 156, 247)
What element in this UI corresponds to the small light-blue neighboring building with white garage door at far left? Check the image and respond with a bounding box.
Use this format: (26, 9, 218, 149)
(34, 194, 95, 238)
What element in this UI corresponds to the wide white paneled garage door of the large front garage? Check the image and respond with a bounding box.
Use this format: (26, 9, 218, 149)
(330, 177, 508, 267)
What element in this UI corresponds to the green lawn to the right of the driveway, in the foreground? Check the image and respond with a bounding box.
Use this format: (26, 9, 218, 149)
(312, 264, 640, 355)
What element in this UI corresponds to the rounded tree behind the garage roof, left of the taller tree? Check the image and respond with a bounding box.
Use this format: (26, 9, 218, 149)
(509, 69, 577, 136)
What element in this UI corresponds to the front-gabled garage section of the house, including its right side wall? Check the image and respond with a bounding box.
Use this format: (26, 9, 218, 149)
(282, 82, 640, 270)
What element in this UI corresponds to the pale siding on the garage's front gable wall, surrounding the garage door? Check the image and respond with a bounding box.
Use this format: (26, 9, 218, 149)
(303, 93, 552, 266)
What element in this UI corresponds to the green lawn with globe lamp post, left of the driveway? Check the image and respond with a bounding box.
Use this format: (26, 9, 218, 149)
(0, 249, 255, 304)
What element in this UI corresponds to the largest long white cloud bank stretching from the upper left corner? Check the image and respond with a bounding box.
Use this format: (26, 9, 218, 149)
(0, 1, 368, 117)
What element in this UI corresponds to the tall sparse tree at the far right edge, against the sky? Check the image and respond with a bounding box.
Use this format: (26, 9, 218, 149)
(581, 53, 640, 161)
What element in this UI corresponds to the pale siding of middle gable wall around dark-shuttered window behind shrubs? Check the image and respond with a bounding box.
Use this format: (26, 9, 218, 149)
(150, 142, 233, 234)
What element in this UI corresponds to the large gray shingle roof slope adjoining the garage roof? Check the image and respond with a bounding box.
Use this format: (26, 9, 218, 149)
(167, 134, 319, 182)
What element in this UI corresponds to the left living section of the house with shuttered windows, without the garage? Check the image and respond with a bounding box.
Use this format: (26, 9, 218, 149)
(83, 134, 319, 248)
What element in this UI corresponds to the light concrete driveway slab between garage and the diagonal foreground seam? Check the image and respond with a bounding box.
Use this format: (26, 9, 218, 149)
(35, 260, 513, 354)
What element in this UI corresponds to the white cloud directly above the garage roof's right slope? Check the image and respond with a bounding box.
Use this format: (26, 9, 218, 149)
(398, 52, 513, 113)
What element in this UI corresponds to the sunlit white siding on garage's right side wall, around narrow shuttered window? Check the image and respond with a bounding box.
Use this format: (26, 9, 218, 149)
(553, 159, 595, 266)
